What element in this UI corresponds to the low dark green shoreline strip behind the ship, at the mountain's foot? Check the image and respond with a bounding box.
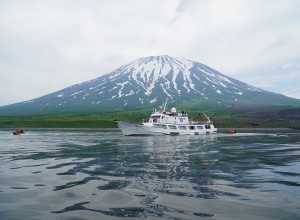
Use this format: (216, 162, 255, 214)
(0, 107, 300, 128)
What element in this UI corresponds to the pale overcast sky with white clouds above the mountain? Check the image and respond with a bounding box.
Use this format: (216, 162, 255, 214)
(0, 0, 300, 106)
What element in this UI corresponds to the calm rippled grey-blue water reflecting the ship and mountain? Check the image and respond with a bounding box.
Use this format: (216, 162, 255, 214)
(0, 130, 300, 220)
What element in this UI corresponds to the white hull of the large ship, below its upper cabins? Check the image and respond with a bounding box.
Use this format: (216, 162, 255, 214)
(116, 121, 217, 136)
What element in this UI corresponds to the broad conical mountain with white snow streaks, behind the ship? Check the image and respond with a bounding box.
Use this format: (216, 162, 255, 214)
(0, 55, 298, 113)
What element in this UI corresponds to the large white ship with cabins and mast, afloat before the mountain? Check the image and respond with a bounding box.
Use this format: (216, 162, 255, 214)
(116, 101, 217, 136)
